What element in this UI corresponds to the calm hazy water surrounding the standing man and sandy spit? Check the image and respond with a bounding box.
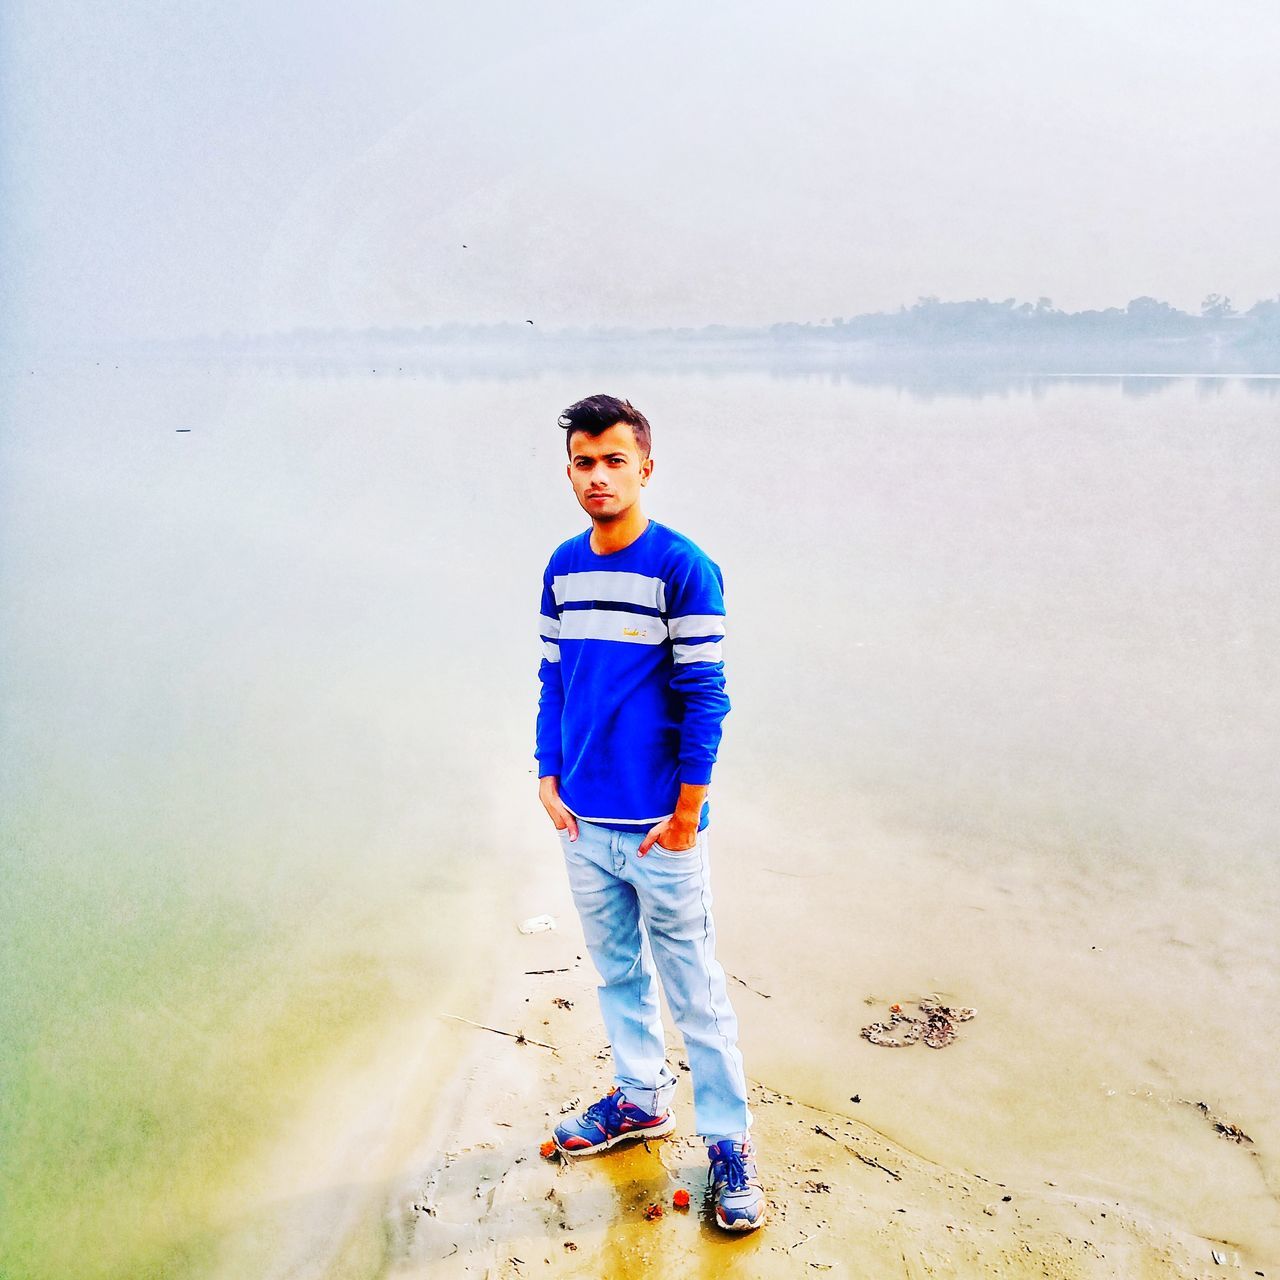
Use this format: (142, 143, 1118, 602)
(0, 370, 1280, 1276)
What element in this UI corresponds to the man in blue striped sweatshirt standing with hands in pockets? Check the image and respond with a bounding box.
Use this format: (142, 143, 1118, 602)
(536, 396, 765, 1230)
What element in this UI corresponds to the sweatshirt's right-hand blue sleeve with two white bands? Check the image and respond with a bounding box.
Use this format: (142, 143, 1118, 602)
(667, 554, 730, 786)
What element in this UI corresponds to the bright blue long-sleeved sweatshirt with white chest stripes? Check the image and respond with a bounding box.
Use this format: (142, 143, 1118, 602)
(536, 520, 730, 831)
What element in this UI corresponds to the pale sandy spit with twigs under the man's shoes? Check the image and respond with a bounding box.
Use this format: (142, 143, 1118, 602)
(366, 922, 1267, 1280)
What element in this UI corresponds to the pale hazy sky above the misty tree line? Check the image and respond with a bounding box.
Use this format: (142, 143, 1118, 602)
(0, 0, 1280, 342)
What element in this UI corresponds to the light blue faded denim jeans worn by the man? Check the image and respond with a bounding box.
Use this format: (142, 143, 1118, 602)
(559, 819, 751, 1142)
